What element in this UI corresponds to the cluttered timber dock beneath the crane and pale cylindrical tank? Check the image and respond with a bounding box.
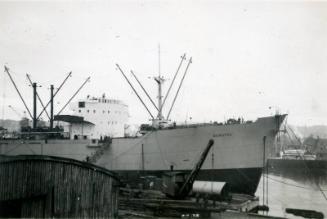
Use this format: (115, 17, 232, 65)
(119, 188, 275, 218)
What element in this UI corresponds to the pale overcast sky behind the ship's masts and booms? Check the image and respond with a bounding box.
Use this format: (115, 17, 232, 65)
(0, 0, 327, 125)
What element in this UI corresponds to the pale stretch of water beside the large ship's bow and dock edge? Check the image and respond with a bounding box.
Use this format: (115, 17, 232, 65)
(256, 169, 327, 218)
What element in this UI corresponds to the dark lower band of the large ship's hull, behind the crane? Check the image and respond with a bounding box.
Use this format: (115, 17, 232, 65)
(116, 168, 262, 195)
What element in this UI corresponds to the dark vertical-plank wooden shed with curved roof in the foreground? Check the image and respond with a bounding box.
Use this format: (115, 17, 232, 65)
(0, 155, 119, 218)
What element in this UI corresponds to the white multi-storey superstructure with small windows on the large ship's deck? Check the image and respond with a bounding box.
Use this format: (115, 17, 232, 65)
(70, 94, 129, 139)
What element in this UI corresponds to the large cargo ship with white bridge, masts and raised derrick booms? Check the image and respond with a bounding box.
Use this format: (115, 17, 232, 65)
(0, 58, 286, 195)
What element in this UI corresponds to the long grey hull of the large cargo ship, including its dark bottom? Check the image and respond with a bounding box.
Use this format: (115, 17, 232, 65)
(0, 115, 285, 195)
